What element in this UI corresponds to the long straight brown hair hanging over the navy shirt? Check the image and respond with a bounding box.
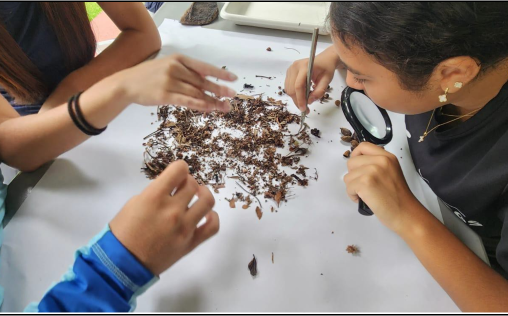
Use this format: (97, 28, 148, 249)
(0, 2, 96, 103)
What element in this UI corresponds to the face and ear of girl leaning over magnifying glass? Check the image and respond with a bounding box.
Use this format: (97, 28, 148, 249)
(333, 37, 443, 115)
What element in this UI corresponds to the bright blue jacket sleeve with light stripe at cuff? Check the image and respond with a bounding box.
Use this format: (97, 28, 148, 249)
(25, 228, 157, 313)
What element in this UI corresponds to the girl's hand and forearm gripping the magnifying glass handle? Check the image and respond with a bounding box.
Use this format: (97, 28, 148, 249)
(344, 143, 508, 312)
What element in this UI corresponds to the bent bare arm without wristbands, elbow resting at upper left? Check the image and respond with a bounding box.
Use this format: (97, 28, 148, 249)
(41, 2, 161, 113)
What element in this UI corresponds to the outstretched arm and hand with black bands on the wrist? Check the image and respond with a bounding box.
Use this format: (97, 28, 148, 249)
(0, 55, 236, 171)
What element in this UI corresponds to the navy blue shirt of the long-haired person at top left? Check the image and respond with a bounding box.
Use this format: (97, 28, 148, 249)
(0, 2, 70, 115)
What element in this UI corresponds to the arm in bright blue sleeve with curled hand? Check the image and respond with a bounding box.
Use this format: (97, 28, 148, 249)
(26, 161, 219, 313)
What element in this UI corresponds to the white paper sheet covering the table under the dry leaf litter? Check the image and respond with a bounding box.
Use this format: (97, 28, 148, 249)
(0, 20, 459, 312)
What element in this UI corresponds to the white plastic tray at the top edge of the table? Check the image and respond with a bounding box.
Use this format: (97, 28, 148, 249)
(220, 2, 331, 35)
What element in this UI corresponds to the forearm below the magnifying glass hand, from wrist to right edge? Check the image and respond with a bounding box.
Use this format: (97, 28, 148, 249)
(400, 203, 508, 312)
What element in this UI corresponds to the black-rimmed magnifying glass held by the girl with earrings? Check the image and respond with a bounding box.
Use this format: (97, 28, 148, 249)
(341, 87, 393, 216)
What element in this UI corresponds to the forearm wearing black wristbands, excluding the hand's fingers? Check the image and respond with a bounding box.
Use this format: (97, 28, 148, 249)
(0, 77, 129, 171)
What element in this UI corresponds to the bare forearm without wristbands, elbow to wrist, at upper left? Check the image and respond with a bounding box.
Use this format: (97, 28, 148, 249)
(40, 16, 161, 113)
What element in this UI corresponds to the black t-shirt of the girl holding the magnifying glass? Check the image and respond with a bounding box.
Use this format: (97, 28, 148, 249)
(406, 83, 508, 277)
